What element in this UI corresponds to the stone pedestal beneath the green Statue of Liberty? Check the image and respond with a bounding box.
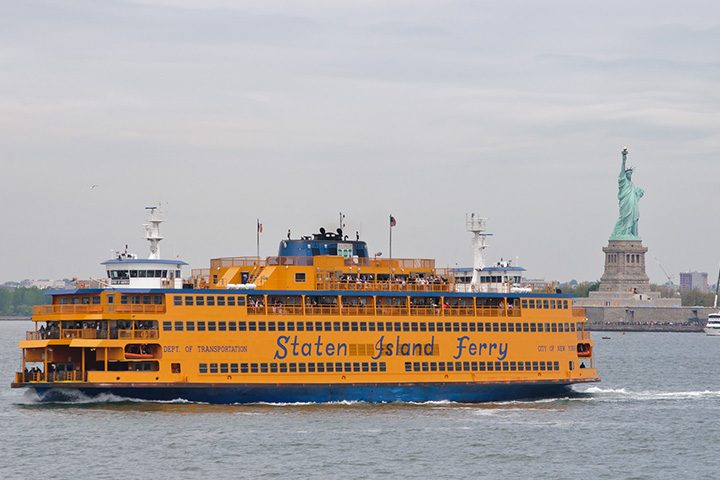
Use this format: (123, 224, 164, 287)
(599, 239, 650, 294)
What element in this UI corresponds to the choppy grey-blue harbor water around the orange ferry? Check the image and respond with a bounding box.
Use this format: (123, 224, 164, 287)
(0, 322, 720, 479)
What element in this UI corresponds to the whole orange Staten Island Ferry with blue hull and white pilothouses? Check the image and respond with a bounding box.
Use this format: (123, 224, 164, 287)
(12, 208, 599, 403)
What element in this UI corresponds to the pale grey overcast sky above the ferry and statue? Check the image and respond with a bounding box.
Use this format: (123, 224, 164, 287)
(0, 0, 720, 283)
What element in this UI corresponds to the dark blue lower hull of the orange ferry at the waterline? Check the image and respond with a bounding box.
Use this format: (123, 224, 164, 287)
(25, 380, 596, 404)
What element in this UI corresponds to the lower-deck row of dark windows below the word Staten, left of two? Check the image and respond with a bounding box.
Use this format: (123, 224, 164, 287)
(199, 362, 387, 373)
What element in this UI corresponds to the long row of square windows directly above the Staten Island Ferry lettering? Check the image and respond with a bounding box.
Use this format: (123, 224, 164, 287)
(163, 320, 580, 333)
